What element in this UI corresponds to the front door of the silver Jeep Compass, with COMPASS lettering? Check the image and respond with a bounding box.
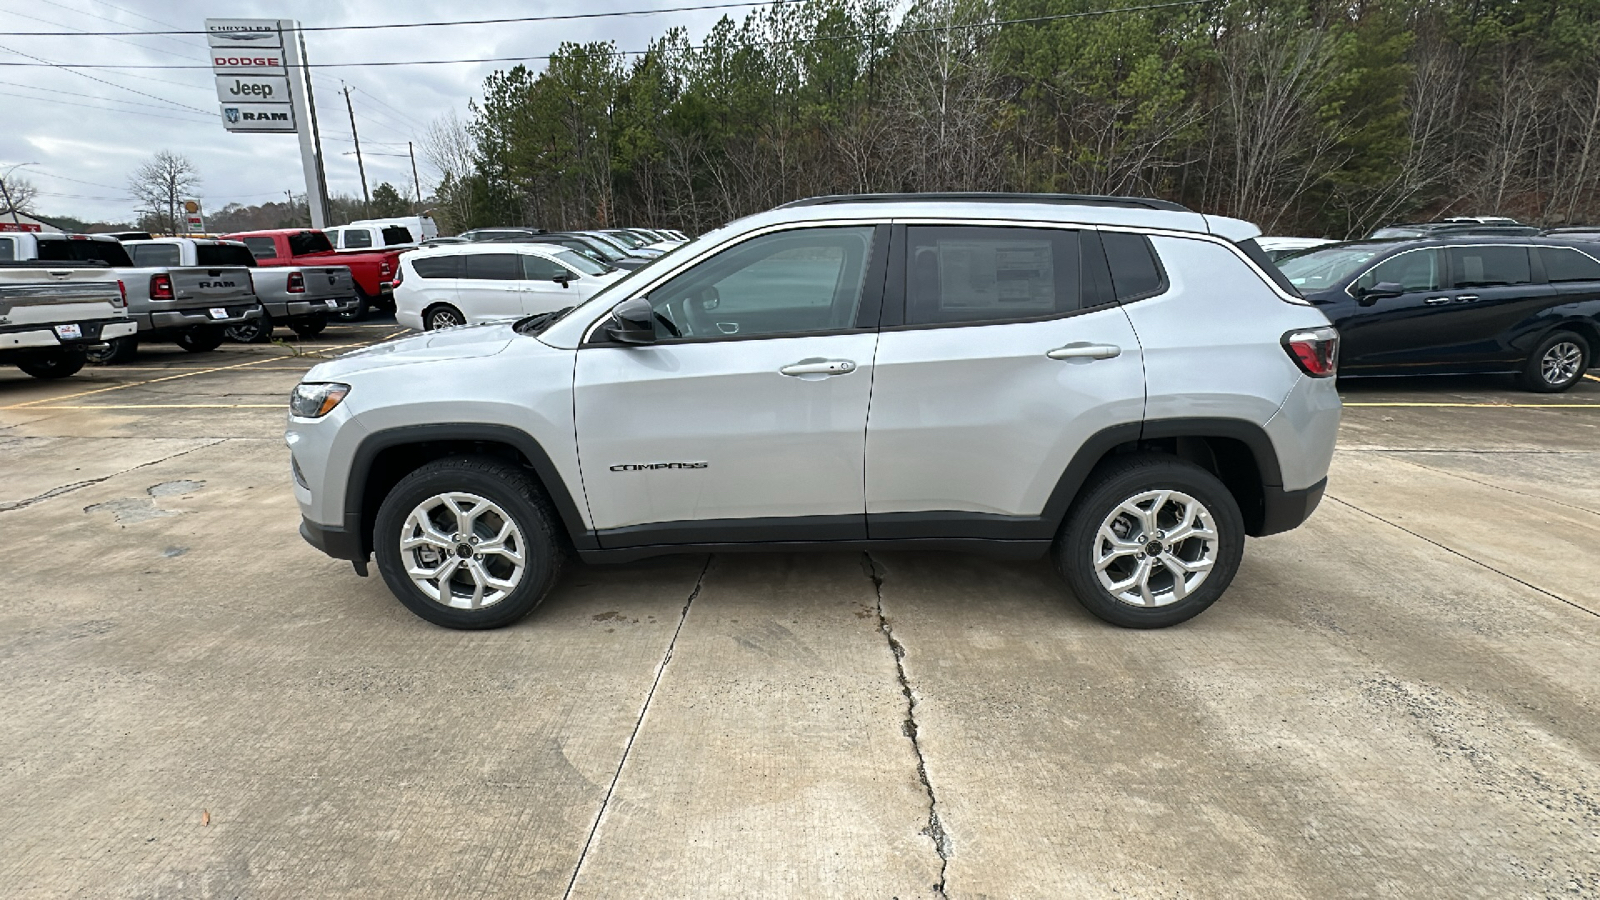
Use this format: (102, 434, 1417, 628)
(574, 226, 886, 548)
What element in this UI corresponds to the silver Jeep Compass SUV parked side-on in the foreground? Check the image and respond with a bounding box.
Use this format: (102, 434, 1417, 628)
(288, 194, 1339, 628)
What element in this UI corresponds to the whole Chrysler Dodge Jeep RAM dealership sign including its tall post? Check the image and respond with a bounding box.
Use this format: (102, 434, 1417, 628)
(205, 19, 328, 229)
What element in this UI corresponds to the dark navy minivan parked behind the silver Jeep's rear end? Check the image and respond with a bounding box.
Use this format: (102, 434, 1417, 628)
(1278, 232, 1600, 391)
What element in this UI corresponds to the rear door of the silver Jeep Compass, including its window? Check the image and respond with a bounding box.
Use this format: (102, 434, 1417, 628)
(866, 223, 1150, 540)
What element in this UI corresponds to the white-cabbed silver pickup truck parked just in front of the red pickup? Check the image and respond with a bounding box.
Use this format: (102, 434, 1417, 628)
(122, 237, 362, 344)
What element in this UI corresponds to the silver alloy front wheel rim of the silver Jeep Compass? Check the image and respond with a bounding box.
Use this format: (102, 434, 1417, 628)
(400, 492, 528, 610)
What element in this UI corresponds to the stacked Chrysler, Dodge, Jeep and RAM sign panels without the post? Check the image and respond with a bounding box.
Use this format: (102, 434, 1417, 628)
(205, 19, 299, 133)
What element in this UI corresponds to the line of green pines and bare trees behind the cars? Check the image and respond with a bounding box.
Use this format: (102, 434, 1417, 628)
(424, 0, 1600, 237)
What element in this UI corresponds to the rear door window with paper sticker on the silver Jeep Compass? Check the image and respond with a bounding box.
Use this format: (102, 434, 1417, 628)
(906, 226, 1082, 325)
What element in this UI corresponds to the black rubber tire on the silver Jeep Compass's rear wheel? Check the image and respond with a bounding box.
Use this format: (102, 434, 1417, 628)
(1053, 453, 1245, 628)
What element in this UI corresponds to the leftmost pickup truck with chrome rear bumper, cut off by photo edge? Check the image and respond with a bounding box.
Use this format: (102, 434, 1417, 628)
(0, 259, 138, 378)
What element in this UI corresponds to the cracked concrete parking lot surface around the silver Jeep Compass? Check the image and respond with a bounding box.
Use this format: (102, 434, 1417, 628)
(0, 325, 1600, 898)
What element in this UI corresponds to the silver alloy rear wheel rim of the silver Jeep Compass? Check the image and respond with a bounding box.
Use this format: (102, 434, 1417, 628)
(1093, 490, 1218, 607)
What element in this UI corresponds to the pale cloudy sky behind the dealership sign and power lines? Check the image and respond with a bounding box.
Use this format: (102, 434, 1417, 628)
(0, 0, 742, 221)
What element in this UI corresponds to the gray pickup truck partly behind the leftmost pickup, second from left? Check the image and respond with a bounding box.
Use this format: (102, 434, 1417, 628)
(0, 232, 261, 364)
